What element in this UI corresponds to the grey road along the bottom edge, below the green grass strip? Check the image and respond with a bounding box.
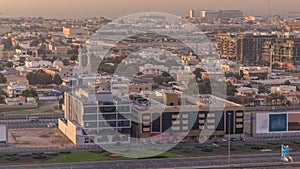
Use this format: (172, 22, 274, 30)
(0, 153, 300, 169)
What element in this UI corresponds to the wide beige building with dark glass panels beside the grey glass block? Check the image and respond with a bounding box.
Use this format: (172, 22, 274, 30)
(132, 91, 244, 141)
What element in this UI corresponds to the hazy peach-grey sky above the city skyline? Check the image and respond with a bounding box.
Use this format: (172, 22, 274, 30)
(0, 0, 300, 18)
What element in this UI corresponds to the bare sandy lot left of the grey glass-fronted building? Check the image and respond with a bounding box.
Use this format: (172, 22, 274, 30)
(8, 128, 73, 147)
